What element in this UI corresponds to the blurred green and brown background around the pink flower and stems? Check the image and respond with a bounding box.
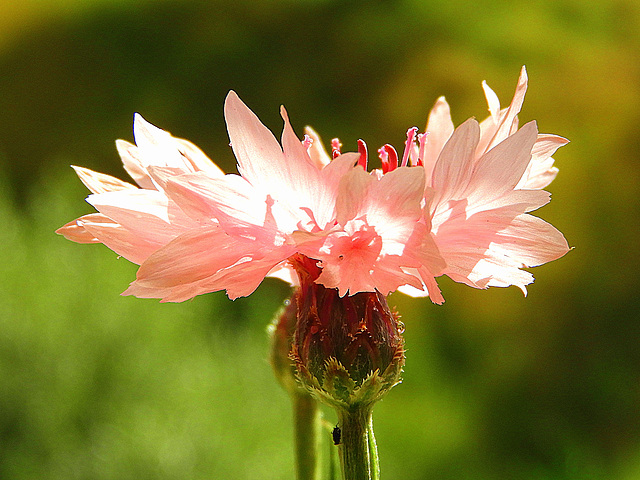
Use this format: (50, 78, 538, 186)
(0, 0, 640, 480)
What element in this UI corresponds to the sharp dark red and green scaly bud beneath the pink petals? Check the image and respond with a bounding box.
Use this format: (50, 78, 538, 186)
(291, 257, 404, 409)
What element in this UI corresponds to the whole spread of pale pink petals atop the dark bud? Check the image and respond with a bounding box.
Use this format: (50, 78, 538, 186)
(58, 68, 568, 303)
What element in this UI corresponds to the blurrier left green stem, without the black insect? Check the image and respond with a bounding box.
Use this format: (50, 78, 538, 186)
(291, 392, 321, 480)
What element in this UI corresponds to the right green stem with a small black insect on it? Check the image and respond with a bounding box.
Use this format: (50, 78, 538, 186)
(338, 406, 379, 480)
